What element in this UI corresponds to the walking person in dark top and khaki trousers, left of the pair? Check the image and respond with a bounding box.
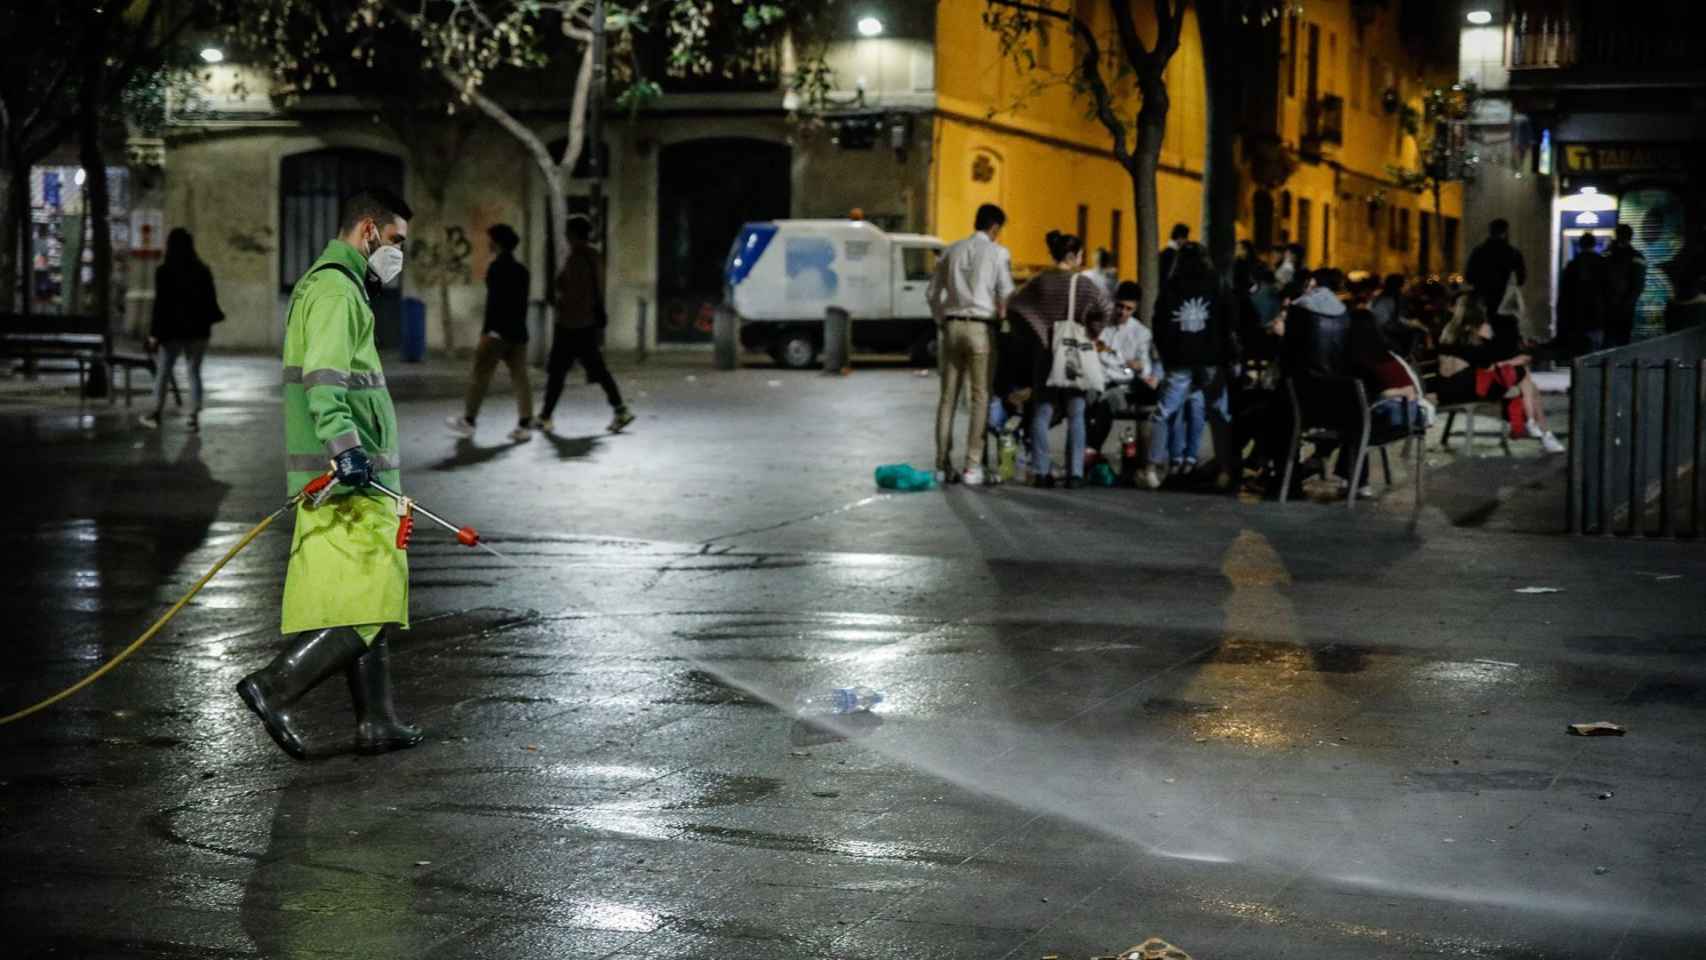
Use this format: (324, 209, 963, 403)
(445, 223, 532, 443)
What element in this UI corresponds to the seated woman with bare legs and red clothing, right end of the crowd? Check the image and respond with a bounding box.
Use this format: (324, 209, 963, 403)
(1428, 292, 1564, 454)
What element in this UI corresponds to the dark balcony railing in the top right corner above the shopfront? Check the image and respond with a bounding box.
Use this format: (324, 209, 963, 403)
(1505, 0, 1706, 73)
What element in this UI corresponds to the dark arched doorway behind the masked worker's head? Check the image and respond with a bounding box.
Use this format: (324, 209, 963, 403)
(278, 147, 403, 350)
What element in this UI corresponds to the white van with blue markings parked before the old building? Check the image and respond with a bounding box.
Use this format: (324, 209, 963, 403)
(723, 220, 945, 368)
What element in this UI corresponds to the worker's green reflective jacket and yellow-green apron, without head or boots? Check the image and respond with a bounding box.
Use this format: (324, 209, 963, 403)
(281, 240, 409, 641)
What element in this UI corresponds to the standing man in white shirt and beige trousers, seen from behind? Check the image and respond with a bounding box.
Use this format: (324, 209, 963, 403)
(925, 203, 1013, 484)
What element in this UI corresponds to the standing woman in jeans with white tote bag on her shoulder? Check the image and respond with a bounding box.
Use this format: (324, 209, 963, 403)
(1008, 230, 1112, 489)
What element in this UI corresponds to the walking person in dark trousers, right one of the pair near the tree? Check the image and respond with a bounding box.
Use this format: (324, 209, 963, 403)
(536, 217, 635, 433)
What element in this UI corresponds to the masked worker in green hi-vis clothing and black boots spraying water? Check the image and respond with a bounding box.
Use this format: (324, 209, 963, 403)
(237, 189, 421, 760)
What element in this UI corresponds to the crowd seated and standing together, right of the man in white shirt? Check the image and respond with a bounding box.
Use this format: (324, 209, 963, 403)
(988, 234, 1564, 496)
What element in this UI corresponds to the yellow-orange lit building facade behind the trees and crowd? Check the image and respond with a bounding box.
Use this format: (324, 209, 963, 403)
(928, 0, 1462, 278)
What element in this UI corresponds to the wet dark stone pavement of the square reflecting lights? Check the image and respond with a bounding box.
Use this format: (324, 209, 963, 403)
(0, 358, 1706, 960)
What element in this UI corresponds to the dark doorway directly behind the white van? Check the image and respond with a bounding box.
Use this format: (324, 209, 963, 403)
(657, 138, 792, 343)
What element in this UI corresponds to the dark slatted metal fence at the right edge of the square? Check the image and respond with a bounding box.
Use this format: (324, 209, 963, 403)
(1568, 327, 1706, 537)
